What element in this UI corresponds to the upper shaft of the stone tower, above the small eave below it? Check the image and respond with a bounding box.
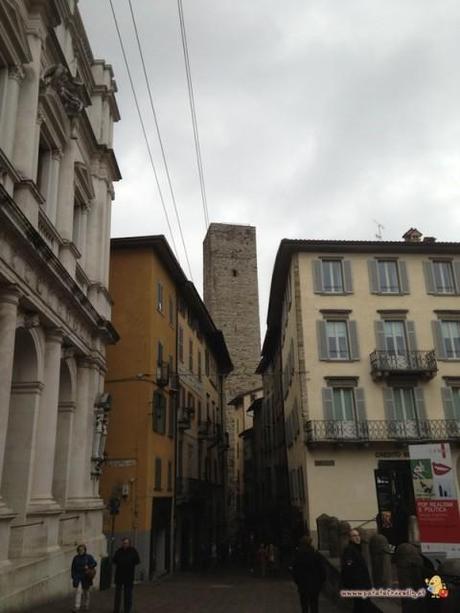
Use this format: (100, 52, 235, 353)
(203, 223, 261, 402)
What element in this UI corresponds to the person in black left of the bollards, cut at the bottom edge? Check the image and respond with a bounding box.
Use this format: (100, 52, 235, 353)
(292, 536, 326, 613)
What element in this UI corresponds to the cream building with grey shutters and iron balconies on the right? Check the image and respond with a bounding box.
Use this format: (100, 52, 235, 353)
(259, 229, 460, 541)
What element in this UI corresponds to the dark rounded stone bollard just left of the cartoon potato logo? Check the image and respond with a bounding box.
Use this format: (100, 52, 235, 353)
(394, 543, 426, 613)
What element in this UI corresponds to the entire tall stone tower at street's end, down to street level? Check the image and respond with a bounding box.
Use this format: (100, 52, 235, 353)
(203, 223, 262, 541)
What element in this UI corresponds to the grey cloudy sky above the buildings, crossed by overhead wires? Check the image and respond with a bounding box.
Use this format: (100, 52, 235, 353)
(79, 0, 460, 329)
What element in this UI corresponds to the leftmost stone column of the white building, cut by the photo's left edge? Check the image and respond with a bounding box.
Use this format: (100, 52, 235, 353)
(0, 285, 20, 512)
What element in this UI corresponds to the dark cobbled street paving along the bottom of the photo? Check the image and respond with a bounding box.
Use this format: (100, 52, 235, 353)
(30, 571, 349, 613)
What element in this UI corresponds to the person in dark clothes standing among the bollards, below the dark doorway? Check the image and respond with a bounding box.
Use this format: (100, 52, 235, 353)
(342, 529, 373, 613)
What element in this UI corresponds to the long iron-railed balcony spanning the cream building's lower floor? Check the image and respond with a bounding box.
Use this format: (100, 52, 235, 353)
(305, 419, 460, 445)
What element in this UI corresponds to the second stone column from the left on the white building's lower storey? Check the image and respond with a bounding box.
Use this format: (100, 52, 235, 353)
(28, 328, 63, 512)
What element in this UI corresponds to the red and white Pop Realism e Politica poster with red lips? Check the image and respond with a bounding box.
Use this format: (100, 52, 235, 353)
(409, 443, 460, 553)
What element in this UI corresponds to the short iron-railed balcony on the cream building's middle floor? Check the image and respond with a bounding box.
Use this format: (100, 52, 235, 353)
(369, 349, 438, 379)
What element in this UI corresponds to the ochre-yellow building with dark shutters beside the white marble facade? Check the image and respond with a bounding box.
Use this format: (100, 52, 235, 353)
(102, 236, 230, 578)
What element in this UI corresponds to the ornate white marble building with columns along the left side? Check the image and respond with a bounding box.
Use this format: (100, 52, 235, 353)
(0, 0, 120, 611)
